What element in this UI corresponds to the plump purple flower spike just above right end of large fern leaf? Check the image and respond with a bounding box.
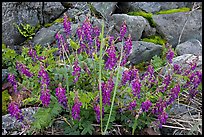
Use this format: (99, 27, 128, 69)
(55, 84, 67, 108)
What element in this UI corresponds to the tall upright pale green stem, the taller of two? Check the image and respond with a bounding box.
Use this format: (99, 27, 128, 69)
(99, 21, 104, 135)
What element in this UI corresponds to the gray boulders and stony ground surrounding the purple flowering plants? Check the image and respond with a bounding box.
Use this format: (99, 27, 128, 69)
(2, 2, 202, 134)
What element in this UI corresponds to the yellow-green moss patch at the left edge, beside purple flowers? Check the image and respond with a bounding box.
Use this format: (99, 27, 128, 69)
(2, 90, 10, 115)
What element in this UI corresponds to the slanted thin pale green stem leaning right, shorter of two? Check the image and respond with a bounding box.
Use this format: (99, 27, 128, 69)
(103, 41, 123, 135)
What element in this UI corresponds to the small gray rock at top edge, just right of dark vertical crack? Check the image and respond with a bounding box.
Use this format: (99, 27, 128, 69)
(43, 2, 66, 23)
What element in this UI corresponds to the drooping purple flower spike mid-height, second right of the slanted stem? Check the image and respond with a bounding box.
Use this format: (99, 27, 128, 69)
(131, 78, 142, 98)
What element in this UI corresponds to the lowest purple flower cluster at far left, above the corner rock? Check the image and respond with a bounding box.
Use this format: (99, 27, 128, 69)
(8, 101, 23, 121)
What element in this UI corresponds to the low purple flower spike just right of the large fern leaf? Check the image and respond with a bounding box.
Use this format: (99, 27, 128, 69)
(72, 98, 82, 120)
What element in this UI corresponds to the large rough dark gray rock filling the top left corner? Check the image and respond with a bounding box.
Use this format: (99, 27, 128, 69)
(2, 2, 42, 48)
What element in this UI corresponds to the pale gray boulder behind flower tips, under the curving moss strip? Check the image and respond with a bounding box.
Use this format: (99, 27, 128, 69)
(110, 14, 149, 41)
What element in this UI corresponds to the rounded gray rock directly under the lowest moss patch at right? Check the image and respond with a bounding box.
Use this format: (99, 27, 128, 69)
(116, 41, 162, 65)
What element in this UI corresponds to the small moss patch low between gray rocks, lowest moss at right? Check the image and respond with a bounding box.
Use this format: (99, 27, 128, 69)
(142, 35, 166, 45)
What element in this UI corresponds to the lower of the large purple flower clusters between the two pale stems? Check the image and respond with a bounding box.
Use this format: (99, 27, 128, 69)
(101, 78, 114, 105)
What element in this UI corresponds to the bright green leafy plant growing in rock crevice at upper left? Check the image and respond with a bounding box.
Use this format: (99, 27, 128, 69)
(14, 23, 40, 39)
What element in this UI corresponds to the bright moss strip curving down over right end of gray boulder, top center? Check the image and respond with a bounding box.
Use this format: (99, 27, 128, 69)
(127, 11, 156, 27)
